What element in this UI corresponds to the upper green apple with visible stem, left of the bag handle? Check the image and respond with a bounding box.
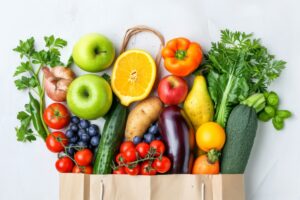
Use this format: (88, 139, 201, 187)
(72, 33, 115, 72)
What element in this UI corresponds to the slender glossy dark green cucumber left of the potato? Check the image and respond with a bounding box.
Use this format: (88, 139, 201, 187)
(93, 102, 128, 174)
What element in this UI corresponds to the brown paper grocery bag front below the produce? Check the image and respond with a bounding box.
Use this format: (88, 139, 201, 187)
(60, 174, 245, 200)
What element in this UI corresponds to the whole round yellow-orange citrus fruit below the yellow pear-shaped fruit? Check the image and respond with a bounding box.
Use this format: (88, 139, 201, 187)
(196, 122, 226, 152)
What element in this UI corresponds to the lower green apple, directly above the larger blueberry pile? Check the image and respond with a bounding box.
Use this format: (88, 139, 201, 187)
(67, 74, 113, 119)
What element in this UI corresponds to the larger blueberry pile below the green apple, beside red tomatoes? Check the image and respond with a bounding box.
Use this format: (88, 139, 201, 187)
(65, 116, 101, 156)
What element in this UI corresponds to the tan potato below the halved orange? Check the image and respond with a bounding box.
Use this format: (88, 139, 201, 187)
(125, 97, 163, 141)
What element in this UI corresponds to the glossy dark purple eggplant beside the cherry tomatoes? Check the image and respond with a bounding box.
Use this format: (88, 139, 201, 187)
(158, 106, 190, 174)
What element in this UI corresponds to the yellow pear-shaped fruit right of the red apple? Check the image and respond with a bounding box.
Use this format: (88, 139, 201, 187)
(183, 75, 214, 131)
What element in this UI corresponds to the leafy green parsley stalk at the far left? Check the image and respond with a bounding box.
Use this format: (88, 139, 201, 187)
(13, 35, 70, 142)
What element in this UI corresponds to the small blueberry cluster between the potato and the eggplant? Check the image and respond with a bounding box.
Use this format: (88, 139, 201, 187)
(133, 122, 161, 145)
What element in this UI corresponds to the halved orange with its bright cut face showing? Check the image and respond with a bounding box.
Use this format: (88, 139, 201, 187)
(111, 49, 156, 106)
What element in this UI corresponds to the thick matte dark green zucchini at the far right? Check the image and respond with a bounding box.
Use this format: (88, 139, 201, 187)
(221, 104, 257, 174)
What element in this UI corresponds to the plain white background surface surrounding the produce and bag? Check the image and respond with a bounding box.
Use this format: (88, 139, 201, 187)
(0, 0, 300, 200)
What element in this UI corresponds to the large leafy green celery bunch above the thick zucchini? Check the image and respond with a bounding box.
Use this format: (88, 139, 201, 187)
(204, 30, 285, 127)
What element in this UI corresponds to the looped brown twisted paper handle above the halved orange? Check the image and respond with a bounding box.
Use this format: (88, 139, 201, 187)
(120, 25, 165, 66)
